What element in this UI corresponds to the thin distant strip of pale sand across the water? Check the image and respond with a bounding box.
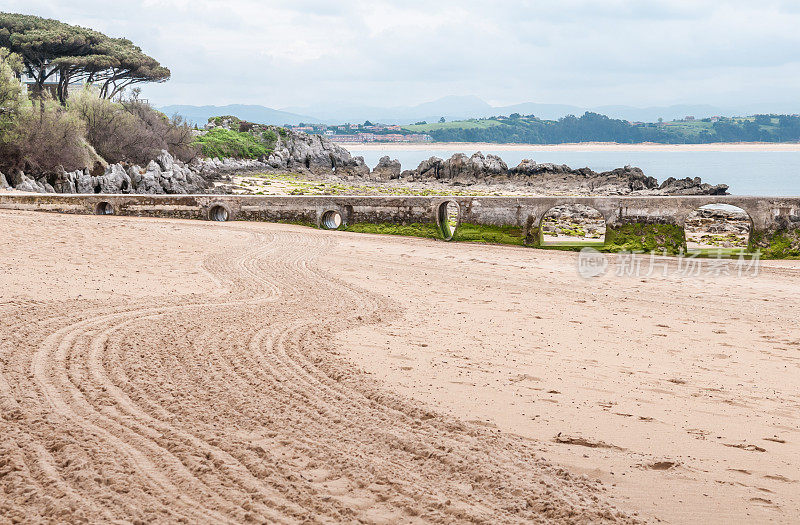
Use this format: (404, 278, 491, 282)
(339, 142, 800, 153)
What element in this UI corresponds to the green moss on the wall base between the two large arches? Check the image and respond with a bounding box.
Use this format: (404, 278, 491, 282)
(601, 223, 686, 255)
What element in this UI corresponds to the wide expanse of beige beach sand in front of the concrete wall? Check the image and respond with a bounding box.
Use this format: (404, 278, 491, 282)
(0, 211, 800, 523)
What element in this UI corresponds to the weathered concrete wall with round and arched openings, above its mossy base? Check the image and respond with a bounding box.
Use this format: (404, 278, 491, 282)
(0, 194, 800, 242)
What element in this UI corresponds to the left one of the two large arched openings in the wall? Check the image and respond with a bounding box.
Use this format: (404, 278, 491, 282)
(539, 204, 606, 246)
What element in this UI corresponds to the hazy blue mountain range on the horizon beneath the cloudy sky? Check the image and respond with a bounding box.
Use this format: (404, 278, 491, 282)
(159, 96, 798, 125)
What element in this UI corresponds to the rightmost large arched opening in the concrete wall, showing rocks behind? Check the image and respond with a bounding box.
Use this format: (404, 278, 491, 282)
(684, 204, 753, 252)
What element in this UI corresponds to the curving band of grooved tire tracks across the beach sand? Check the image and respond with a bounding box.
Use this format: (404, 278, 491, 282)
(0, 215, 627, 523)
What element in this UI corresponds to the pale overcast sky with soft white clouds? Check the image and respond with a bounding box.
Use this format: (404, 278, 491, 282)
(2, 0, 800, 108)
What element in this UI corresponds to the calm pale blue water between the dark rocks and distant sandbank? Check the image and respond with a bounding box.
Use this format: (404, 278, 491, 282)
(348, 147, 800, 196)
